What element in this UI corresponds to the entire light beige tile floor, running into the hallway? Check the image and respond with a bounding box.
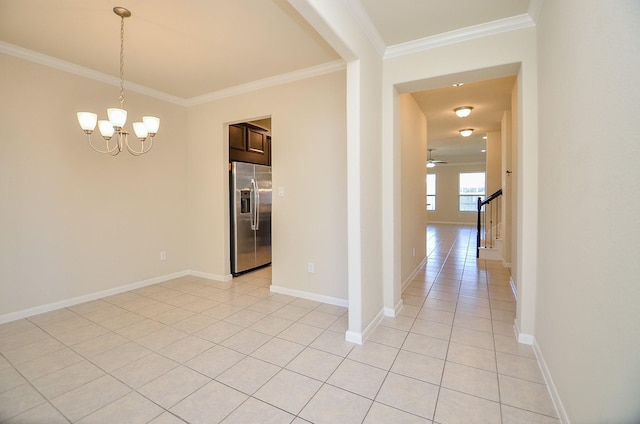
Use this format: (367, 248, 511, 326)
(0, 225, 559, 424)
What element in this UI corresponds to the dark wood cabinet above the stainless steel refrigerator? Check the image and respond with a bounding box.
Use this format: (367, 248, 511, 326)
(229, 123, 271, 165)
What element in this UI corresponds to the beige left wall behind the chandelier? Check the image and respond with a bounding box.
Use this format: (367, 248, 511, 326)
(0, 55, 187, 320)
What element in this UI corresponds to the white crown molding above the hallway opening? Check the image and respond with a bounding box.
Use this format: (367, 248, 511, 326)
(384, 13, 537, 59)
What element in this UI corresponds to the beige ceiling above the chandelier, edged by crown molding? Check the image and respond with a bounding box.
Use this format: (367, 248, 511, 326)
(0, 0, 340, 99)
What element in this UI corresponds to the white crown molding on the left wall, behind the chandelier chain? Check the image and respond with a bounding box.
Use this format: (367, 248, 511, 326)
(0, 41, 185, 106)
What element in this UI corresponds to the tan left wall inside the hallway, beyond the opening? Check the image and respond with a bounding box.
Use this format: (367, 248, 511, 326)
(400, 94, 427, 283)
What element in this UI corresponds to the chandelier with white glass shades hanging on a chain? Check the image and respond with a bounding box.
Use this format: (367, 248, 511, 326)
(78, 7, 160, 156)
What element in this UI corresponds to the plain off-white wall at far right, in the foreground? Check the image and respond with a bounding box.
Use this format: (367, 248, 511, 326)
(535, 0, 640, 423)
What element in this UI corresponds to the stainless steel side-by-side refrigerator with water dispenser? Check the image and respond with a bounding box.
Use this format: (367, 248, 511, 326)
(229, 162, 272, 276)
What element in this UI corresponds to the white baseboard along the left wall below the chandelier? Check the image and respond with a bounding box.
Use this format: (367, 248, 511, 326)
(0, 271, 190, 324)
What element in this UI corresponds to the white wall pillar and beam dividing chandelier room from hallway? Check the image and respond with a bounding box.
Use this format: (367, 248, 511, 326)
(289, 0, 384, 342)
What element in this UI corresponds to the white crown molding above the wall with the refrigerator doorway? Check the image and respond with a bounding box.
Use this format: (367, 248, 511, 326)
(185, 60, 346, 106)
